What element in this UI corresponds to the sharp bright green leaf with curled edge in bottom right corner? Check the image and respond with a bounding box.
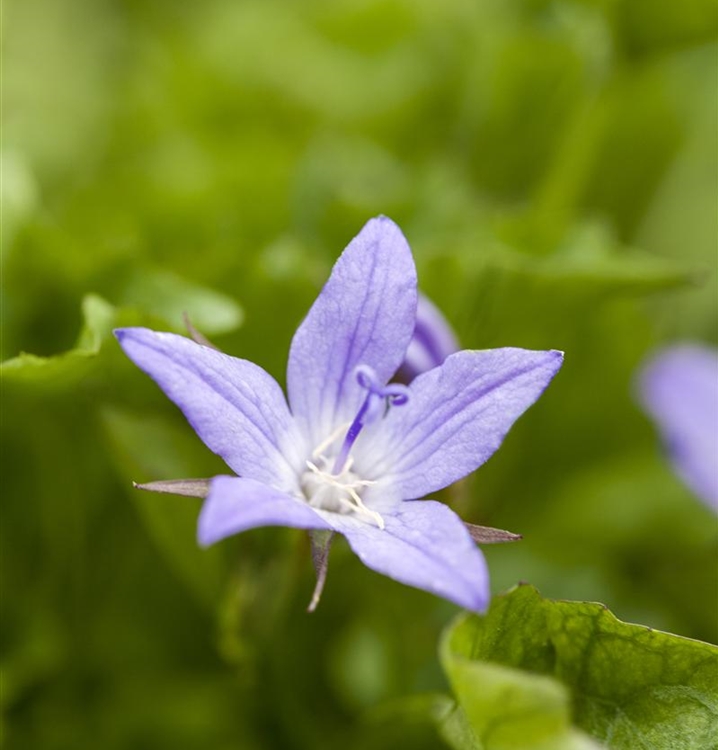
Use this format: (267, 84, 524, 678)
(441, 586, 718, 750)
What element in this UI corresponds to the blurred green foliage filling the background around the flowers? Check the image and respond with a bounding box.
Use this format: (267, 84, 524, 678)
(0, 0, 718, 750)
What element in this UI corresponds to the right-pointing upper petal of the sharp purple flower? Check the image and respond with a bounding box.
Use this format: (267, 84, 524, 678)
(372, 348, 563, 498)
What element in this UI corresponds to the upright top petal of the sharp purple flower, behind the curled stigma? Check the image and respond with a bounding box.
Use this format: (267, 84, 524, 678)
(287, 216, 416, 445)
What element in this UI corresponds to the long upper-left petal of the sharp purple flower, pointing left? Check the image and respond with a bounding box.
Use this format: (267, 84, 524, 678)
(115, 328, 301, 491)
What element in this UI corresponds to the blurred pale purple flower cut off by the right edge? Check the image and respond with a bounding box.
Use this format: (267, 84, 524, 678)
(639, 344, 718, 510)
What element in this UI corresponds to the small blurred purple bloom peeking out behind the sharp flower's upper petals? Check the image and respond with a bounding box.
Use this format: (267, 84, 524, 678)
(397, 293, 459, 383)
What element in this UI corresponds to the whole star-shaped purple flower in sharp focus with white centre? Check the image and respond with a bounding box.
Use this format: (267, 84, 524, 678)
(116, 217, 562, 611)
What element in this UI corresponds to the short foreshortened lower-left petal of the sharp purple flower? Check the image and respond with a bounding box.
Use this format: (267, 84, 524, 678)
(197, 476, 331, 546)
